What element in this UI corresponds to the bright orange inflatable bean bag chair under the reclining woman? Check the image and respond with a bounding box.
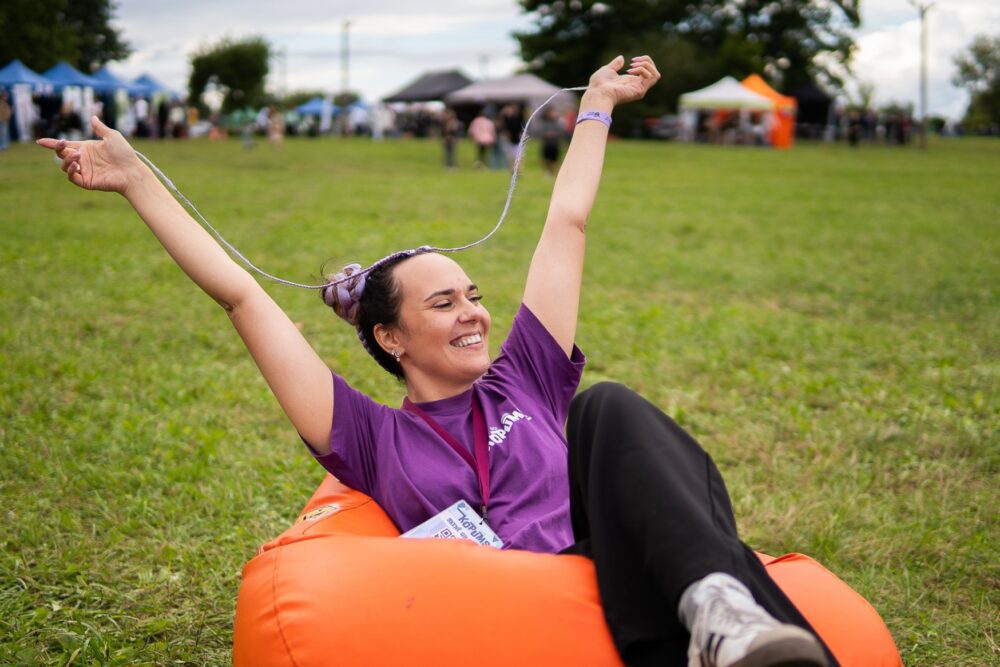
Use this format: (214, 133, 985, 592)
(233, 475, 902, 667)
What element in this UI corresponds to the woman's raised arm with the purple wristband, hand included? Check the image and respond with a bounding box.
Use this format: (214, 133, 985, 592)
(523, 56, 660, 354)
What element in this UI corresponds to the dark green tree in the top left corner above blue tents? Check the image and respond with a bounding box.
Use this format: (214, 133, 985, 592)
(0, 0, 131, 71)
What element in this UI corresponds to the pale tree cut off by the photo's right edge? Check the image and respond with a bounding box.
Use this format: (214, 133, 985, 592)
(952, 35, 1000, 133)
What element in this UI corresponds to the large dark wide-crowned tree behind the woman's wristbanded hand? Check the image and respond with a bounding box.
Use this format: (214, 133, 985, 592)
(515, 0, 860, 126)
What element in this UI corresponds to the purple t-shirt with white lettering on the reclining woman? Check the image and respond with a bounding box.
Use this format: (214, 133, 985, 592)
(316, 304, 586, 553)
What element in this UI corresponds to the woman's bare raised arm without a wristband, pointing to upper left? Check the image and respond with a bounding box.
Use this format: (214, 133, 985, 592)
(38, 117, 333, 453)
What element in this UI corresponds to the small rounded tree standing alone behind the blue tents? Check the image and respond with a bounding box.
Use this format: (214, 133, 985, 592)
(188, 37, 271, 112)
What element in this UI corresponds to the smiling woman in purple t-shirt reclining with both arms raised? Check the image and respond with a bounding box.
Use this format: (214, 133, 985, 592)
(39, 56, 832, 667)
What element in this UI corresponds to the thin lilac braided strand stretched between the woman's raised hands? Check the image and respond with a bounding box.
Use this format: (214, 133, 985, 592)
(135, 86, 587, 289)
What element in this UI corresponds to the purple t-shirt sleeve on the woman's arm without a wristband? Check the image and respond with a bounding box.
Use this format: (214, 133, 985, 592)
(309, 373, 389, 495)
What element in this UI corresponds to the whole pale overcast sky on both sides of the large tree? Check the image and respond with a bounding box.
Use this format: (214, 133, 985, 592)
(112, 0, 1000, 118)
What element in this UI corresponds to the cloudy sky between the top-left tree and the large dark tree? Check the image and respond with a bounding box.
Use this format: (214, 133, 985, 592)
(114, 0, 530, 99)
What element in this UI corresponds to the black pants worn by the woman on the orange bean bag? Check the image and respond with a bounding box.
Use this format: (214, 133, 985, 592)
(567, 383, 837, 665)
